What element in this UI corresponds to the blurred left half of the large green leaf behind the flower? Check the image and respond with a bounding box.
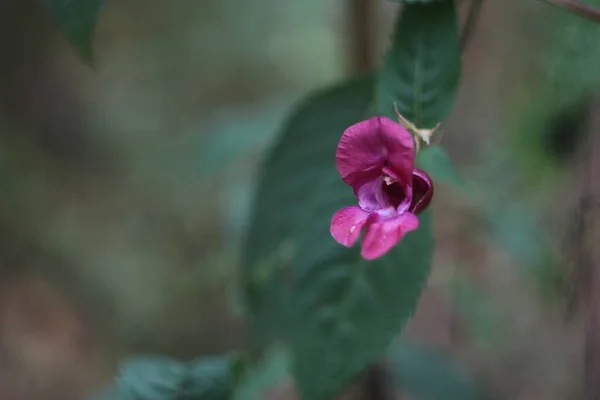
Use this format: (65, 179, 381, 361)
(242, 77, 373, 347)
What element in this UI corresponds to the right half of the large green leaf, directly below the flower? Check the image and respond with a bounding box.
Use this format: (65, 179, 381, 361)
(292, 185, 433, 400)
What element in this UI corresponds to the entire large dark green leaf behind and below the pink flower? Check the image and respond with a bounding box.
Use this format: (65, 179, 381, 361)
(244, 73, 433, 400)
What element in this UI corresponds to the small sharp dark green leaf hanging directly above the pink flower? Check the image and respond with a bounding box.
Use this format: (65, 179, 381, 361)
(376, 0, 460, 129)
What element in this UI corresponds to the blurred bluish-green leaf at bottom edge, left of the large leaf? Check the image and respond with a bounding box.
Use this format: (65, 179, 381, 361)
(95, 356, 244, 400)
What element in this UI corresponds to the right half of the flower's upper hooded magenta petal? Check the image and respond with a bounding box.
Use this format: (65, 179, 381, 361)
(379, 117, 415, 185)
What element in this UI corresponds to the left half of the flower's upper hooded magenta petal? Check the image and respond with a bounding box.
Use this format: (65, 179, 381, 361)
(335, 117, 388, 187)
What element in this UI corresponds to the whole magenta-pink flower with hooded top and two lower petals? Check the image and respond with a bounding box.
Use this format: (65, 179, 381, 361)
(330, 117, 433, 260)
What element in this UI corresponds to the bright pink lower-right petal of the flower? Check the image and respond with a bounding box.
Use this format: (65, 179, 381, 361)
(361, 213, 419, 260)
